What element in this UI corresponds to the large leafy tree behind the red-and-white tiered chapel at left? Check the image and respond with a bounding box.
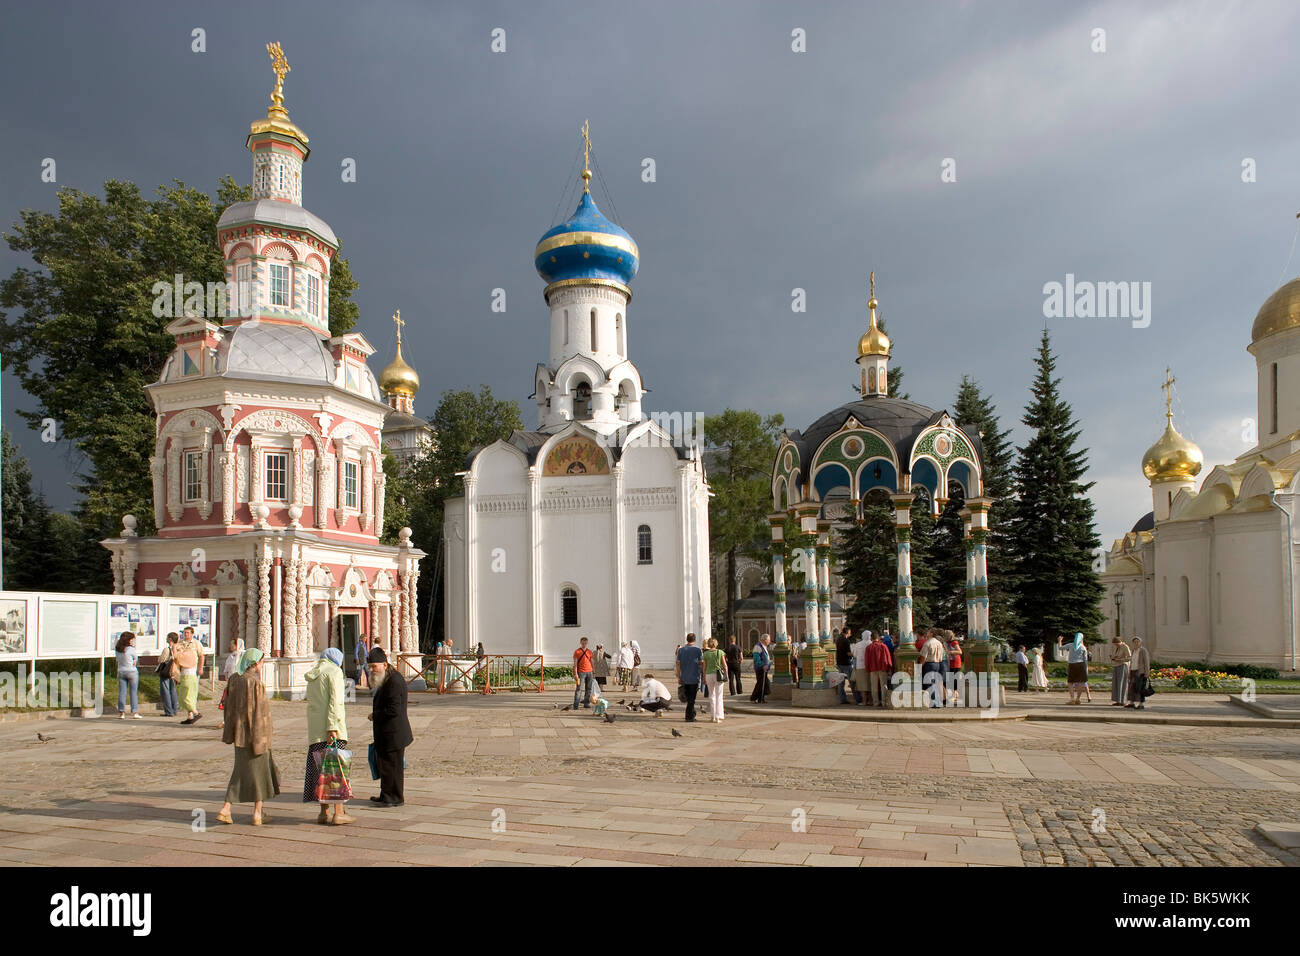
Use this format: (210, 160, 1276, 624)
(0, 176, 356, 588)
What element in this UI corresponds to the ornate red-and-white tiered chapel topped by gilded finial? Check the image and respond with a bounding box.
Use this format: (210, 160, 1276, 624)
(101, 43, 424, 696)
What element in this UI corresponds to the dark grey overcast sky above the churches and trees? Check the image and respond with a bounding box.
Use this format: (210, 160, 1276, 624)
(0, 0, 1300, 545)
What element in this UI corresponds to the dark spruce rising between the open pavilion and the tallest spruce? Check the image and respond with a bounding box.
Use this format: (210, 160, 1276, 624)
(953, 375, 1019, 640)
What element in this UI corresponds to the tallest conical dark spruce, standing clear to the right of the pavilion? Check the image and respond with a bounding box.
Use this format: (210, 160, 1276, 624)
(1006, 329, 1102, 643)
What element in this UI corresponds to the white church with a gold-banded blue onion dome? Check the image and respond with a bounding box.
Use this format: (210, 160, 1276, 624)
(443, 127, 710, 666)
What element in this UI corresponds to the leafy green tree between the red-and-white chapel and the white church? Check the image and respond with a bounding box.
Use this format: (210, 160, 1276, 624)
(403, 385, 524, 646)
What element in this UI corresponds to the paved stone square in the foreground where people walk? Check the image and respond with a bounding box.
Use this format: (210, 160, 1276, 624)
(0, 692, 1300, 866)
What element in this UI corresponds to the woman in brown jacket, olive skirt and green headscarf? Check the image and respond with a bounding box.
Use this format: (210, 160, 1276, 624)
(217, 648, 280, 826)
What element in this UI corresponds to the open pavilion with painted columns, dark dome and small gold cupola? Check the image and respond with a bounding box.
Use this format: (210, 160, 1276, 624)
(768, 273, 993, 706)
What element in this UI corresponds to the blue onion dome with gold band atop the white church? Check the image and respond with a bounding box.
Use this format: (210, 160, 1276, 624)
(533, 193, 638, 291)
